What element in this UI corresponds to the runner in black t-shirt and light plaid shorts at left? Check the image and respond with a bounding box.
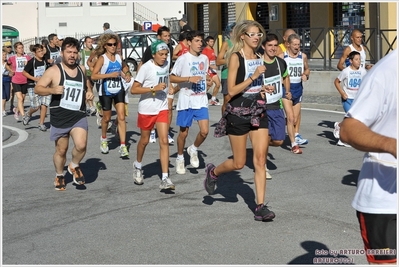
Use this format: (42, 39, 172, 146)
(22, 44, 51, 132)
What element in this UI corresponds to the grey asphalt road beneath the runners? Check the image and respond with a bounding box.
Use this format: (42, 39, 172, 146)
(2, 96, 367, 265)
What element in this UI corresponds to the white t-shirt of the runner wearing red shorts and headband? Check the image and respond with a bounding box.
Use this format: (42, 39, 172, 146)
(135, 59, 170, 115)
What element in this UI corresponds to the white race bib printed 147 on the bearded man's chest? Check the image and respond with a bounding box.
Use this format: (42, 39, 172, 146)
(60, 80, 84, 111)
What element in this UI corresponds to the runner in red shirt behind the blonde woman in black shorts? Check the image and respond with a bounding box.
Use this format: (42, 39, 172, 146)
(202, 36, 220, 106)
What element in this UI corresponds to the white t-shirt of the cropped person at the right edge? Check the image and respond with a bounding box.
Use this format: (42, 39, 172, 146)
(346, 49, 398, 214)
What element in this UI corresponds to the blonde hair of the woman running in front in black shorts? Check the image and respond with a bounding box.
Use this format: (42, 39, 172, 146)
(226, 20, 266, 66)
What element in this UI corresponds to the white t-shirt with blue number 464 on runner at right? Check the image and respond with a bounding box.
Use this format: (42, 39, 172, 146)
(338, 66, 367, 99)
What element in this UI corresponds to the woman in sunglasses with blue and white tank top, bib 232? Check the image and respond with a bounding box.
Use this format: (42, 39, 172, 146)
(91, 34, 131, 158)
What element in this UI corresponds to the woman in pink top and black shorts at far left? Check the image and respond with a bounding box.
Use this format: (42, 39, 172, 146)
(8, 42, 30, 121)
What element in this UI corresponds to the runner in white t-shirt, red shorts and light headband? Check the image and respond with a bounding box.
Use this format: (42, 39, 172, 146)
(131, 40, 175, 190)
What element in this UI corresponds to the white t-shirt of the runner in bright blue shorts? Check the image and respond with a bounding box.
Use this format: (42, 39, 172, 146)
(171, 53, 209, 110)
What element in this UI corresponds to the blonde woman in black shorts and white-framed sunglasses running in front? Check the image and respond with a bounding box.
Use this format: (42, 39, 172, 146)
(204, 20, 275, 221)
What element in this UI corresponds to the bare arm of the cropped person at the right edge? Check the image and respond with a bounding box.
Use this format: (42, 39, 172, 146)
(340, 118, 397, 158)
